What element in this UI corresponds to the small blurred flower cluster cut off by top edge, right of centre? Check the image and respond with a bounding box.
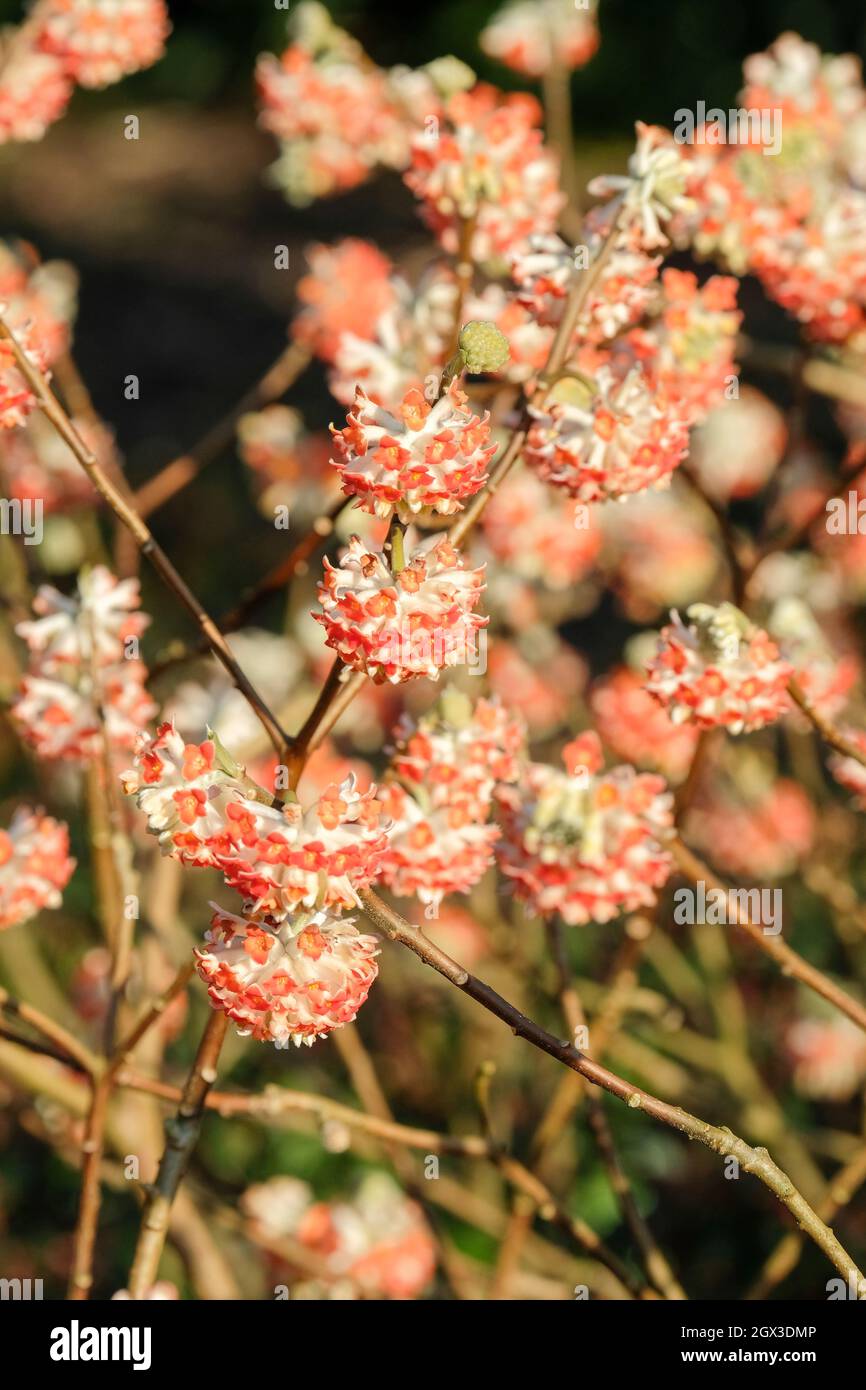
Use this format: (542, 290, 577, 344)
(480, 0, 599, 78)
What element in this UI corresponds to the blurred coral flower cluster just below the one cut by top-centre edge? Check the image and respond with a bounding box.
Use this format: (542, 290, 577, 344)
(406, 83, 564, 265)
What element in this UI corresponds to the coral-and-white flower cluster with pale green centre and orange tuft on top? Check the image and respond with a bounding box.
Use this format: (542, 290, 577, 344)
(498, 734, 673, 924)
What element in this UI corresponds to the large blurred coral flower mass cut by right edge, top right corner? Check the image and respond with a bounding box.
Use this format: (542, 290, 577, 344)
(677, 33, 866, 346)
